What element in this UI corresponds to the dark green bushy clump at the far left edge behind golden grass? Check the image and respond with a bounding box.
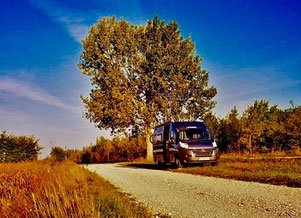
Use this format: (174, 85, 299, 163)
(0, 131, 42, 162)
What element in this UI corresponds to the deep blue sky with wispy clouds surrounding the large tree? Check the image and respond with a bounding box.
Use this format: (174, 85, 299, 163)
(0, 0, 301, 156)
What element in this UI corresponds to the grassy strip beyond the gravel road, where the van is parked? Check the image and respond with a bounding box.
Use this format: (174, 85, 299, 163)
(128, 153, 301, 187)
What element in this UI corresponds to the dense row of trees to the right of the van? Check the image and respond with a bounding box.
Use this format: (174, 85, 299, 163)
(204, 100, 301, 153)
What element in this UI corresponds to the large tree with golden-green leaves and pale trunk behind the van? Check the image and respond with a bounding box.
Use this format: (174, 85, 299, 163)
(78, 16, 217, 159)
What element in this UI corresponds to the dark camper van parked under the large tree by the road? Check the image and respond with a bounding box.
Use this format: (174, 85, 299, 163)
(150, 121, 219, 168)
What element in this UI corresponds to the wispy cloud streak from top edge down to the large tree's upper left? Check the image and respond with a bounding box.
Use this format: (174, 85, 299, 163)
(30, 0, 89, 42)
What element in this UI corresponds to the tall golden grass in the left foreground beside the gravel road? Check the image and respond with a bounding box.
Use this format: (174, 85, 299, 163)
(0, 161, 151, 217)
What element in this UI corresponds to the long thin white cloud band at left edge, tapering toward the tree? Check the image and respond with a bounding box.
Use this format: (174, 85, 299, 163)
(0, 78, 79, 112)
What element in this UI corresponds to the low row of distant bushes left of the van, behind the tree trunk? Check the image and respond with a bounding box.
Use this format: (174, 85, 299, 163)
(50, 136, 146, 163)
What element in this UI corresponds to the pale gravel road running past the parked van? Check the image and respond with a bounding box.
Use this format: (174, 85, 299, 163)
(88, 164, 301, 217)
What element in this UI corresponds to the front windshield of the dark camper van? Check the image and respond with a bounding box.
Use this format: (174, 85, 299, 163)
(178, 128, 212, 141)
